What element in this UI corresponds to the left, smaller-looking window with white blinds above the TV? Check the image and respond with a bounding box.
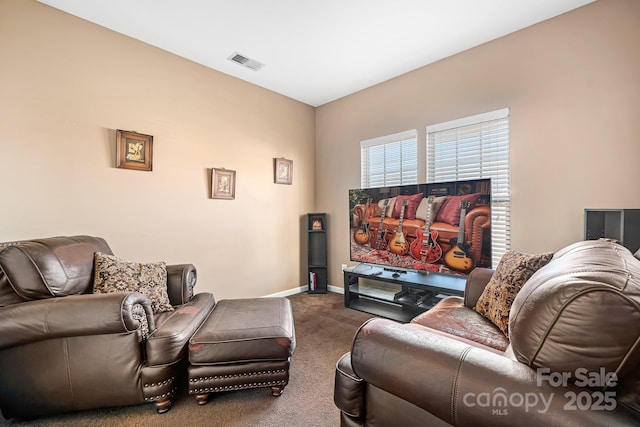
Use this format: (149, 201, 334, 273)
(360, 129, 418, 188)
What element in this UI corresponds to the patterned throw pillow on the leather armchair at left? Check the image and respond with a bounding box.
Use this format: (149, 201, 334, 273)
(93, 252, 173, 313)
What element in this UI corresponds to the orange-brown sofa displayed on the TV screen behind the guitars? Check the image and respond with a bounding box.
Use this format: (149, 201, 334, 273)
(353, 204, 491, 265)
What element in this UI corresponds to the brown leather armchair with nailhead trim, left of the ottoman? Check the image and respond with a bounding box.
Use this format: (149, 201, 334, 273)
(0, 236, 215, 419)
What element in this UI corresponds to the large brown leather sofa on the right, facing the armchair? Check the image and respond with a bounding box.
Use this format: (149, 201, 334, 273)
(334, 241, 640, 427)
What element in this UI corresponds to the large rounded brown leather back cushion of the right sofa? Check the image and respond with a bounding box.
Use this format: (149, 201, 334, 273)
(509, 240, 640, 377)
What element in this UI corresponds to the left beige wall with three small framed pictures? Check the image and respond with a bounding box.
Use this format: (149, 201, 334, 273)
(0, 0, 315, 299)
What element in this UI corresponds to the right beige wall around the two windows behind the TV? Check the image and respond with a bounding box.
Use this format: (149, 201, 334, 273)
(316, 0, 640, 285)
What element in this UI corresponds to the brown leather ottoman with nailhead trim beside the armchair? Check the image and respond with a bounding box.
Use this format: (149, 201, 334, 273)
(188, 298, 296, 405)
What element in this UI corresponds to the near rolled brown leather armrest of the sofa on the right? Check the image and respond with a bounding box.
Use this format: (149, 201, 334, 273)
(351, 319, 638, 427)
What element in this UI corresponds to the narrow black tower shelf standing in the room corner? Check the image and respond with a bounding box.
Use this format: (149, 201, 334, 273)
(307, 213, 328, 294)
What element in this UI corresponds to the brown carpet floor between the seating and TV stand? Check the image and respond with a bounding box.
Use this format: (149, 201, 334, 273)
(0, 293, 373, 427)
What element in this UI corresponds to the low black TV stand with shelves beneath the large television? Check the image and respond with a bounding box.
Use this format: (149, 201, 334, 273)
(344, 264, 467, 322)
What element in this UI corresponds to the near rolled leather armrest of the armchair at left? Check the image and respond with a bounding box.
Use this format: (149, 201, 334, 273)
(0, 292, 155, 349)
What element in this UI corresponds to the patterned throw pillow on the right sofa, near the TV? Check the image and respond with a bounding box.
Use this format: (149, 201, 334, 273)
(475, 250, 553, 336)
